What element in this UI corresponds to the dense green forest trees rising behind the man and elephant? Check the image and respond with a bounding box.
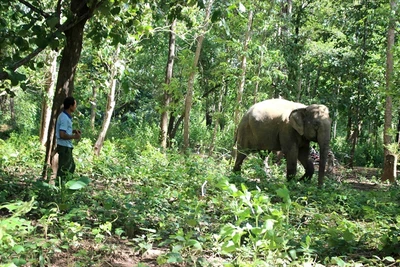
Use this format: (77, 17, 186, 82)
(0, 1, 399, 166)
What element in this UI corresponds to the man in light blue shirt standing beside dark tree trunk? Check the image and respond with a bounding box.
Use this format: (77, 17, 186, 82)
(56, 97, 81, 185)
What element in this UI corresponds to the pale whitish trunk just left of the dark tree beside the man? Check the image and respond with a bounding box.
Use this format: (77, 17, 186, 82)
(39, 51, 58, 145)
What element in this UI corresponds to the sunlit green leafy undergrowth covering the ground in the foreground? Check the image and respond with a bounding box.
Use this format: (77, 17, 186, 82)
(0, 135, 400, 266)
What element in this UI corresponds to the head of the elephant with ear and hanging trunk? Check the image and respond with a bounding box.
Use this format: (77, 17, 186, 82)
(289, 104, 331, 186)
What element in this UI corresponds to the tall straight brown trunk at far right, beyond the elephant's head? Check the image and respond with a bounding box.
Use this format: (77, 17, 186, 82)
(381, 0, 397, 183)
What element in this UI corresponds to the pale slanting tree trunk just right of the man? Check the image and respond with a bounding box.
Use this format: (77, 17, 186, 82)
(94, 45, 120, 156)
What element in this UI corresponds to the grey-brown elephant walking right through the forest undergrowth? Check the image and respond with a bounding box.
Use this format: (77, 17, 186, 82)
(233, 99, 331, 186)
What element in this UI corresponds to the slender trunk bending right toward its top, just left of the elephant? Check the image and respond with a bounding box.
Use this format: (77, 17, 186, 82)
(183, 0, 214, 150)
